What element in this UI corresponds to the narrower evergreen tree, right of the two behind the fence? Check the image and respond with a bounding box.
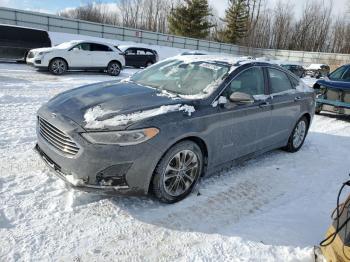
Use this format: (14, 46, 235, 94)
(223, 0, 249, 44)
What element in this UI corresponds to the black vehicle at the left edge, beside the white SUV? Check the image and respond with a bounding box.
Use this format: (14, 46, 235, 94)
(0, 24, 51, 61)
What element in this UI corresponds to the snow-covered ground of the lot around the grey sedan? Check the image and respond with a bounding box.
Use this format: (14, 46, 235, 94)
(0, 63, 350, 261)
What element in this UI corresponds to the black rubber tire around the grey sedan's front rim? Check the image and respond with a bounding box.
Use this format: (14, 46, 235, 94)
(152, 141, 203, 204)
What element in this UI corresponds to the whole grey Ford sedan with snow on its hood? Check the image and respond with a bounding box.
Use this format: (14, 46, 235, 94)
(36, 56, 315, 203)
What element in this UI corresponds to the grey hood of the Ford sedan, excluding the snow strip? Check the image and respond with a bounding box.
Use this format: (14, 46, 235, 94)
(43, 81, 189, 129)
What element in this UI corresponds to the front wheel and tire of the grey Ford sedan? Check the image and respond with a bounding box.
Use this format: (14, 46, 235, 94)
(152, 140, 203, 204)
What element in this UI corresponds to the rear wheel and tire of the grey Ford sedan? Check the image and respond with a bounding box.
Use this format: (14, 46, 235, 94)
(284, 116, 309, 153)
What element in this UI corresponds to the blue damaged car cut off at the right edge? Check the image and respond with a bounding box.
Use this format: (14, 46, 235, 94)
(314, 64, 350, 114)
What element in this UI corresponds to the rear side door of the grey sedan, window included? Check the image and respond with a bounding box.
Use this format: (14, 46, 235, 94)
(266, 67, 307, 144)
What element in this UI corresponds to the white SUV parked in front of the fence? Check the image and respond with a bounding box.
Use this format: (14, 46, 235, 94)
(27, 41, 125, 76)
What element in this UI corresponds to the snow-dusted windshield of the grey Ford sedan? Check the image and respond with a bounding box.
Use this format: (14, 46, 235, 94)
(130, 59, 231, 96)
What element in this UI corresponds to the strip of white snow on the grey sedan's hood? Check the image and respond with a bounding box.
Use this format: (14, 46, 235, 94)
(84, 104, 195, 129)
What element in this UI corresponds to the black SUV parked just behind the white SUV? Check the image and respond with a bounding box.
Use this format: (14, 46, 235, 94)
(116, 46, 159, 67)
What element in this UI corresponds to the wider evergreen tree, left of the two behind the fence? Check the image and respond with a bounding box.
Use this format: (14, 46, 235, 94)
(168, 0, 213, 38)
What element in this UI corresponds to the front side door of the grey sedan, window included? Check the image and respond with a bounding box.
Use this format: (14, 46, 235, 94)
(212, 66, 271, 164)
